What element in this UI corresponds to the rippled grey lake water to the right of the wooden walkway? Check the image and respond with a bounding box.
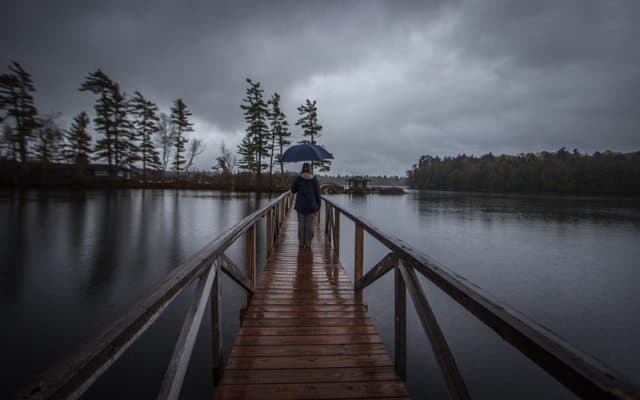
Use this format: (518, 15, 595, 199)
(333, 192, 640, 399)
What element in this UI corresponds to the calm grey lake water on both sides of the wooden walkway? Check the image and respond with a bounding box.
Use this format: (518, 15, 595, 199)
(0, 190, 640, 399)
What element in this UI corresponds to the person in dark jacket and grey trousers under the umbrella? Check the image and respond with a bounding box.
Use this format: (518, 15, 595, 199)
(291, 163, 320, 248)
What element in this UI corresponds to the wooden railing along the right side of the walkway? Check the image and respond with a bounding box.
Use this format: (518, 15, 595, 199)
(323, 196, 640, 399)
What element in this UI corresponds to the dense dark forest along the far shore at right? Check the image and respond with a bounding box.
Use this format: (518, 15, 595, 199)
(407, 147, 640, 195)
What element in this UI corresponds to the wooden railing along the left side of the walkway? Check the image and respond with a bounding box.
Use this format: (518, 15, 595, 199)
(17, 192, 292, 399)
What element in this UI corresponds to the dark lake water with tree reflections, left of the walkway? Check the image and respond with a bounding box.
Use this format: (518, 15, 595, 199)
(0, 190, 272, 398)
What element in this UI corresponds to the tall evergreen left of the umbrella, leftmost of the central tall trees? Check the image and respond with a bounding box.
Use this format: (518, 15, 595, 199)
(238, 78, 270, 188)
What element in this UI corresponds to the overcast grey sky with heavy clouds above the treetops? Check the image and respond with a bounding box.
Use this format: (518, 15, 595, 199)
(0, 0, 640, 175)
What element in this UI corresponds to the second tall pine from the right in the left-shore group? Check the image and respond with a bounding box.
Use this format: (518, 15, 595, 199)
(129, 91, 161, 182)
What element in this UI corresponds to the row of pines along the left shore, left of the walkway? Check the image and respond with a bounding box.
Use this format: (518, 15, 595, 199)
(0, 61, 203, 181)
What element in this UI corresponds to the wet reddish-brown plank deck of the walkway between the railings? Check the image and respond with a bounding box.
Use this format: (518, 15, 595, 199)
(215, 212, 409, 399)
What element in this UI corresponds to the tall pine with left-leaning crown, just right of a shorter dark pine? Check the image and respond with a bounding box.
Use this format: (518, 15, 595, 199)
(79, 69, 117, 168)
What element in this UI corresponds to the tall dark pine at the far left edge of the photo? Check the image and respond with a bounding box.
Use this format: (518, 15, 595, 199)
(0, 61, 38, 163)
